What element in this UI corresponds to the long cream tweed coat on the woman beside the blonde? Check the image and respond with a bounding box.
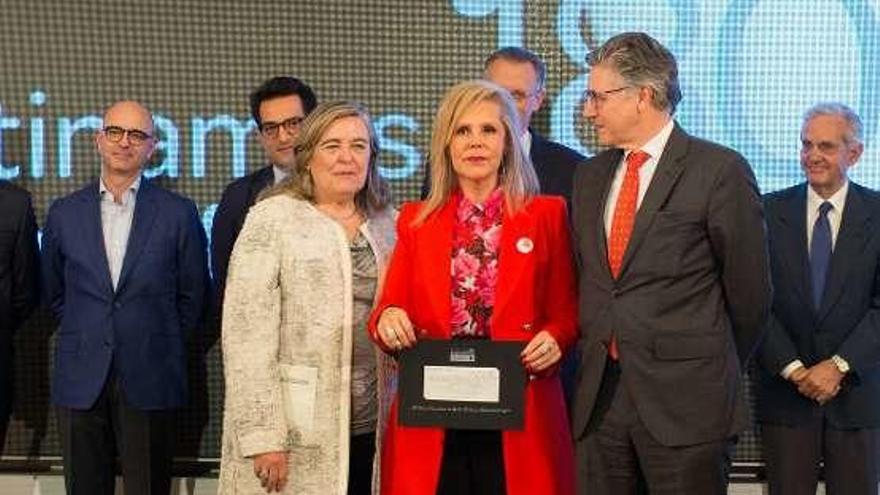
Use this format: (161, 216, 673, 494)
(219, 195, 396, 495)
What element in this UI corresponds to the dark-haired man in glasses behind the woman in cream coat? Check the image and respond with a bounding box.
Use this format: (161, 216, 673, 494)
(211, 76, 318, 306)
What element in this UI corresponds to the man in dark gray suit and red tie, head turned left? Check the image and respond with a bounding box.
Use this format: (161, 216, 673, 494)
(572, 33, 771, 495)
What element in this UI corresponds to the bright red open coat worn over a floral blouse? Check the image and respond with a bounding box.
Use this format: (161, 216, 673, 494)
(368, 196, 577, 495)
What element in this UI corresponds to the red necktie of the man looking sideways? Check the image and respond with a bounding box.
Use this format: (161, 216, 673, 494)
(608, 150, 651, 361)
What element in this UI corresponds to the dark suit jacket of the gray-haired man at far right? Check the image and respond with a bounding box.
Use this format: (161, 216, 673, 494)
(757, 182, 880, 428)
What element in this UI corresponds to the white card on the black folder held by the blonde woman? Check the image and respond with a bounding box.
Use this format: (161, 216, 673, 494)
(422, 365, 501, 402)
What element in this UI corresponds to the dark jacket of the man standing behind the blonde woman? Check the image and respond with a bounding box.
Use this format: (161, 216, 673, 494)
(422, 129, 586, 204)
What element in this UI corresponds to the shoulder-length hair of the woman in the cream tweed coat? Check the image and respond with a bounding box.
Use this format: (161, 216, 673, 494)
(258, 101, 391, 216)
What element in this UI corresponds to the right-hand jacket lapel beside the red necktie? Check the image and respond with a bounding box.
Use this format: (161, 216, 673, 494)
(620, 124, 688, 277)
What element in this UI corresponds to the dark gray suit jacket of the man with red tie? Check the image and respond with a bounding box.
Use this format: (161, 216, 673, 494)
(572, 125, 771, 446)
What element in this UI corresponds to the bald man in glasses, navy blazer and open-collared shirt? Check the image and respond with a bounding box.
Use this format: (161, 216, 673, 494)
(43, 101, 209, 495)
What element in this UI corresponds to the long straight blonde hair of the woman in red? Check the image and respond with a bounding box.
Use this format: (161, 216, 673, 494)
(413, 80, 540, 224)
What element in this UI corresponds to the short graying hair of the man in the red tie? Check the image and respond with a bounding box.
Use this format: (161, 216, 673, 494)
(587, 32, 681, 114)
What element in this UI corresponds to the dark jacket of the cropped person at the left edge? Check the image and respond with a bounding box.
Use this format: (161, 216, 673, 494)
(0, 180, 40, 421)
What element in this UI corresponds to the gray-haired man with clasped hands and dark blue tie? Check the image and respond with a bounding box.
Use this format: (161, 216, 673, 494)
(757, 103, 880, 495)
